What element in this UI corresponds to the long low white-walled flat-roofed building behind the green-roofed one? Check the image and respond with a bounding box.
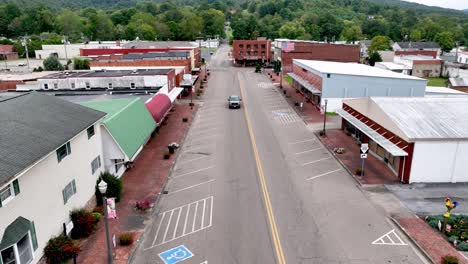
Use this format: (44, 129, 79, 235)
(25, 69, 176, 92)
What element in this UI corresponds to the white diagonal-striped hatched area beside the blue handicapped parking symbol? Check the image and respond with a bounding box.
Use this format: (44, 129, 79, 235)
(150, 196, 213, 248)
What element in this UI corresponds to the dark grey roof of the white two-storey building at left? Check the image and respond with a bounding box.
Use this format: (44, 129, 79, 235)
(0, 92, 105, 186)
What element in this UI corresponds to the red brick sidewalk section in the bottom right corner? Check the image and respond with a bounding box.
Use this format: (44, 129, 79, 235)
(396, 218, 468, 264)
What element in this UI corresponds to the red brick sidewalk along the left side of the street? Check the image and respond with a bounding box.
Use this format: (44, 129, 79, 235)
(77, 104, 197, 264)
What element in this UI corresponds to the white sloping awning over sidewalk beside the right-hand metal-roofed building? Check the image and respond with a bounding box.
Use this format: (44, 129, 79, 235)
(336, 109, 408, 157)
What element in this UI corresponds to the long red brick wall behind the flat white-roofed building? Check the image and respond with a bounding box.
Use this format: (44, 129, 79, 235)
(281, 42, 361, 73)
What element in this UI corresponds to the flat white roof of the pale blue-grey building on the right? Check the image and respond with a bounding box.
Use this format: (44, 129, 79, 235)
(293, 59, 426, 81)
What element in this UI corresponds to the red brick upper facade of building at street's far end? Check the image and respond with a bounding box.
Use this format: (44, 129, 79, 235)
(232, 40, 271, 62)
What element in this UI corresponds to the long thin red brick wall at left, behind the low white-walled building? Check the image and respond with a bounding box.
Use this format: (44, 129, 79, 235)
(91, 59, 191, 72)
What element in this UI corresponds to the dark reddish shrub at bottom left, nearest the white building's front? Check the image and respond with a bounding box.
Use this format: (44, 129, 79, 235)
(44, 235, 80, 264)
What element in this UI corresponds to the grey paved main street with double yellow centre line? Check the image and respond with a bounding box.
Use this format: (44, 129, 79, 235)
(132, 46, 424, 264)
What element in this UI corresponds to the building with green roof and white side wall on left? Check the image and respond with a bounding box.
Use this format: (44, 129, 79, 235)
(81, 98, 157, 177)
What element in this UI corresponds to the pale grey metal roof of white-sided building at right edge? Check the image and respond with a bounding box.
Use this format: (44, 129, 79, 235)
(369, 97, 468, 141)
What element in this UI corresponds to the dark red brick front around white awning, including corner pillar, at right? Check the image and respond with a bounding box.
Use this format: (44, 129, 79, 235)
(342, 103, 414, 183)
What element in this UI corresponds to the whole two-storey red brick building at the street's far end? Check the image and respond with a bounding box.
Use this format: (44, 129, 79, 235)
(232, 39, 271, 65)
